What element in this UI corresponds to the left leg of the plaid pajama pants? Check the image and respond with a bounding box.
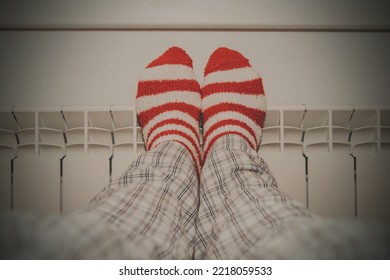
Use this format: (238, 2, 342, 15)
(0, 142, 198, 259)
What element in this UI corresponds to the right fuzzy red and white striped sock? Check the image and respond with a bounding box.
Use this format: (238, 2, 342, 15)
(202, 48, 266, 160)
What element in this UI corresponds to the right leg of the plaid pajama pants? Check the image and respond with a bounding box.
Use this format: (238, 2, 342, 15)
(196, 135, 390, 259)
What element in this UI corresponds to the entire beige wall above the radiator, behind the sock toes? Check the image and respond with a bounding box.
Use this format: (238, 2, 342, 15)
(0, 0, 390, 107)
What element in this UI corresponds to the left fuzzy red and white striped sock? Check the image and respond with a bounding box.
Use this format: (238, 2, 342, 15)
(136, 47, 201, 173)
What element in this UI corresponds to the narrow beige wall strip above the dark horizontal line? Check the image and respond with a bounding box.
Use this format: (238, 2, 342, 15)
(0, 0, 390, 28)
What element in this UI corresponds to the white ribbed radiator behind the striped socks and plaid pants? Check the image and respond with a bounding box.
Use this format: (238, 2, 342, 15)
(0, 105, 390, 222)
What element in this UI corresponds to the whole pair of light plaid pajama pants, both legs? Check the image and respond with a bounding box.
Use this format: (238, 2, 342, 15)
(0, 135, 390, 259)
